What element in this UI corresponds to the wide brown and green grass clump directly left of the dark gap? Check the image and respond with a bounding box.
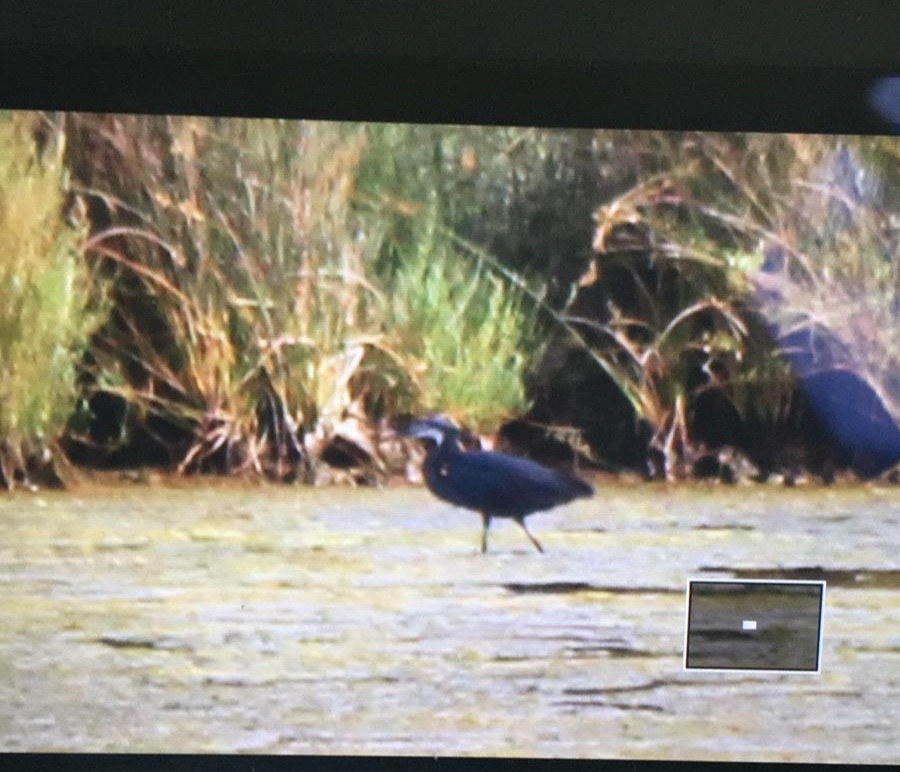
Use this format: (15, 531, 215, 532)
(63, 115, 544, 479)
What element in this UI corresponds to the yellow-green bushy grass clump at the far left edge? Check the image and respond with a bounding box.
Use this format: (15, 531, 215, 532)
(0, 113, 103, 487)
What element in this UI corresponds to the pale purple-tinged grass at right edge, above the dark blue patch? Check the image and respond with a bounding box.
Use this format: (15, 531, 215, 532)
(676, 135, 900, 420)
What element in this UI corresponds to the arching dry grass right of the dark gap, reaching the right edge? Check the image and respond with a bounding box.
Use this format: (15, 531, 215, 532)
(594, 132, 900, 476)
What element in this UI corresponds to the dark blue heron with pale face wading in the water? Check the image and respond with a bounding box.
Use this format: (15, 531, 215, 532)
(405, 416, 594, 552)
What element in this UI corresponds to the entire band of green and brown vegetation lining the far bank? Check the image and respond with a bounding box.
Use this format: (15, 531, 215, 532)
(0, 114, 900, 488)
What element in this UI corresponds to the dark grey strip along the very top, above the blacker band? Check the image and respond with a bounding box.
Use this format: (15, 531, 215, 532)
(0, 0, 900, 68)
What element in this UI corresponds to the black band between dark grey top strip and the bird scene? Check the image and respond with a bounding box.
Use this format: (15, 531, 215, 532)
(0, 46, 900, 134)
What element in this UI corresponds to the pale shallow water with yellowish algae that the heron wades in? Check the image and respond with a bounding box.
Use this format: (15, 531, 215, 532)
(0, 484, 900, 762)
